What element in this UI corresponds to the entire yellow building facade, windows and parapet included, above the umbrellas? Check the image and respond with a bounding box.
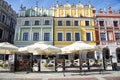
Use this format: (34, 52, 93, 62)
(54, 3, 96, 47)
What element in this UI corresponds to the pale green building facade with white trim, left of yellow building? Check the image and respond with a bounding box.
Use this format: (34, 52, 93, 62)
(14, 5, 53, 47)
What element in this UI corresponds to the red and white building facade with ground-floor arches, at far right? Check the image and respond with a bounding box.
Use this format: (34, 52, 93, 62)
(95, 7, 120, 67)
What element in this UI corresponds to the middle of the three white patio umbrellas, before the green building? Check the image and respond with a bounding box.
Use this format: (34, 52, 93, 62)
(19, 42, 61, 54)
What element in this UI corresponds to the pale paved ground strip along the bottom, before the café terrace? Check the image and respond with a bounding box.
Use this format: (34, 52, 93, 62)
(0, 71, 120, 80)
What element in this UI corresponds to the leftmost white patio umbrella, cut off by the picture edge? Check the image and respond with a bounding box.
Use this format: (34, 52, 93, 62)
(0, 42, 18, 60)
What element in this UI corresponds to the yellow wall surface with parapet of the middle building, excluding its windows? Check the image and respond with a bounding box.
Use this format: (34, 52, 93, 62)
(54, 4, 96, 46)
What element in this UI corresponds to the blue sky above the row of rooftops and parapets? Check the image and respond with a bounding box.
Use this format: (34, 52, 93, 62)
(5, 0, 120, 13)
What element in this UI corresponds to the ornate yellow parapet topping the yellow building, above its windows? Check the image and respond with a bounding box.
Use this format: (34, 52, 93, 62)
(54, 4, 93, 17)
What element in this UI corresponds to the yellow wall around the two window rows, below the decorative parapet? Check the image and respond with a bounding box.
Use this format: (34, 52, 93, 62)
(54, 17, 96, 46)
